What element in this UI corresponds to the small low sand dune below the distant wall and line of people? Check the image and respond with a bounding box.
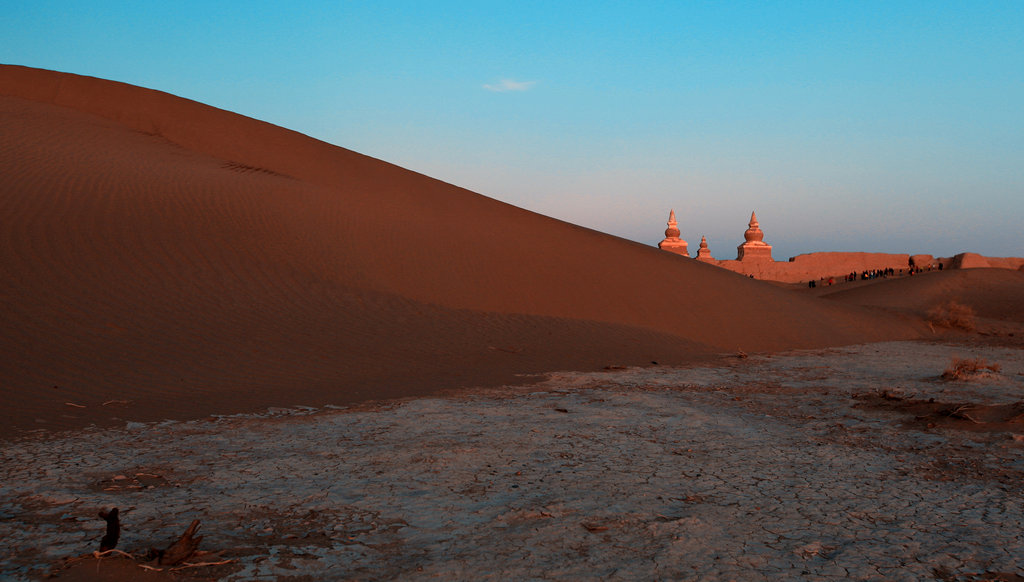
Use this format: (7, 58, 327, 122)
(823, 268, 1024, 323)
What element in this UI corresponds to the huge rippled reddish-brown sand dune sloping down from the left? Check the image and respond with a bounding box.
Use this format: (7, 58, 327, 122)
(0, 66, 921, 429)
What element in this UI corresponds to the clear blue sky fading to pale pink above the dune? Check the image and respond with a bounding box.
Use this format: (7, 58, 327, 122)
(0, 0, 1024, 259)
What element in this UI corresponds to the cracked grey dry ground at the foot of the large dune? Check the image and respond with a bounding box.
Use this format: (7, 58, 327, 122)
(0, 342, 1024, 580)
